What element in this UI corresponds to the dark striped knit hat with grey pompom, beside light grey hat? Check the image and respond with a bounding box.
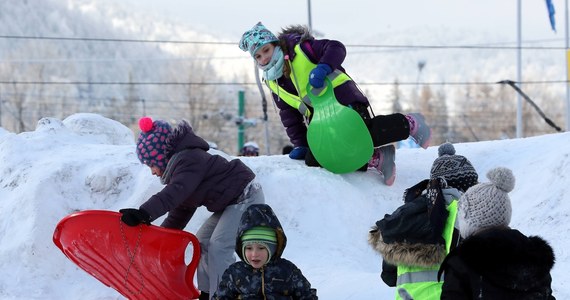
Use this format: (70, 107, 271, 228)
(430, 143, 479, 192)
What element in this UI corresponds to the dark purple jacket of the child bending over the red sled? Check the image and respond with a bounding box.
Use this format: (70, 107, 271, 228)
(140, 121, 255, 229)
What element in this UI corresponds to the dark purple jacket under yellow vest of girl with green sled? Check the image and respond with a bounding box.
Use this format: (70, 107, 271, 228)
(272, 26, 370, 147)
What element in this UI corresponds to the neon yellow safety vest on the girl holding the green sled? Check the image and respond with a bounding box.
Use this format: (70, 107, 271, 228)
(267, 44, 351, 117)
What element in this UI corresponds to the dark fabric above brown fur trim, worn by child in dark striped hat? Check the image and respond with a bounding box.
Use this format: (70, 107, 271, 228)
(376, 179, 449, 244)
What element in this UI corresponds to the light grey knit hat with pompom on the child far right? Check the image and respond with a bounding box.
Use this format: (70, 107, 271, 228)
(457, 167, 515, 238)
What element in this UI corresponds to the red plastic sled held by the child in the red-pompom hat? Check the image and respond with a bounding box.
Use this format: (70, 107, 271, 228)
(53, 210, 200, 300)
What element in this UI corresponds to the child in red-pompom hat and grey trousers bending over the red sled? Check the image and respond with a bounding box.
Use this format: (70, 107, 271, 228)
(120, 117, 265, 299)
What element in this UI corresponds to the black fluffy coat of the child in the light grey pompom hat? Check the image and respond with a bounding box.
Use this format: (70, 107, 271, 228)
(439, 227, 555, 300)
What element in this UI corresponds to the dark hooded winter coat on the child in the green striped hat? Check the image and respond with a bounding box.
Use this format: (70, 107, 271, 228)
(213, 204, 318, 300)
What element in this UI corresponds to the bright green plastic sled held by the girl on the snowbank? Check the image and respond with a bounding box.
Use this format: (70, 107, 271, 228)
(307, 78, 374, 174)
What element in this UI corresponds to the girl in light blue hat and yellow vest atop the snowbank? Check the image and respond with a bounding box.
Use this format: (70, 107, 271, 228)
(239, 22, 431, 185)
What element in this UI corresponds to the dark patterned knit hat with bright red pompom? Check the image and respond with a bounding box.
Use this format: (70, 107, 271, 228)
(137, 117, 172, 171)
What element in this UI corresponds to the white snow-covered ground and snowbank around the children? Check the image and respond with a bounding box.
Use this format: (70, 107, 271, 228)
(0, 114, 570, 299)
